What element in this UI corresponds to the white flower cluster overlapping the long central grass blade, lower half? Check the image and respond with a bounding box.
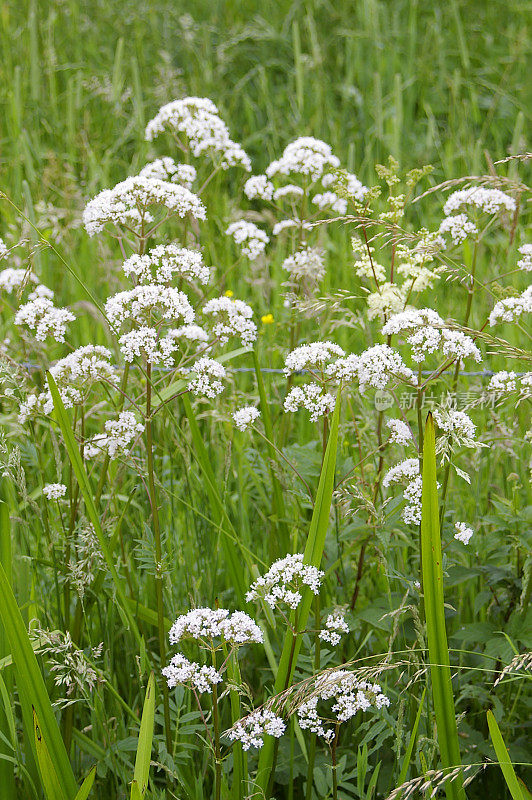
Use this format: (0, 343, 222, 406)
(246, 553, 324, 609)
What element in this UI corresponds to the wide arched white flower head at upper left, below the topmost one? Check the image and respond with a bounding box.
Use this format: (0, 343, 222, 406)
(83, 175, 207, 236)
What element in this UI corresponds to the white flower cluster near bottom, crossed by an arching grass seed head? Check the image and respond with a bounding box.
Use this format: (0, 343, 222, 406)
(297, 669, 390, 742)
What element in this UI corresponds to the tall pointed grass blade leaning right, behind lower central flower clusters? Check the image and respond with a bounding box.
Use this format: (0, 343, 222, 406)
(256, 394, 341, 794)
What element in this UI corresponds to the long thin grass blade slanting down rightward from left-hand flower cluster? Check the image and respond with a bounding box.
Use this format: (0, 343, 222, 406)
(47, 372, 141, 646)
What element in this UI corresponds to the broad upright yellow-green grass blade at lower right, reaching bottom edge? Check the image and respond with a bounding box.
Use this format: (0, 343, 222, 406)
(421, 414, 465, 800)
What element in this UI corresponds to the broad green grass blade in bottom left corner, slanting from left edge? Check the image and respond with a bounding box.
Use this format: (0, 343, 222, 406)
(0, 564, 77, 798)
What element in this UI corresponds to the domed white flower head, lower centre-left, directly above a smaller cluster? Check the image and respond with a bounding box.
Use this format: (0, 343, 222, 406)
(169, 608, 264, 647)
